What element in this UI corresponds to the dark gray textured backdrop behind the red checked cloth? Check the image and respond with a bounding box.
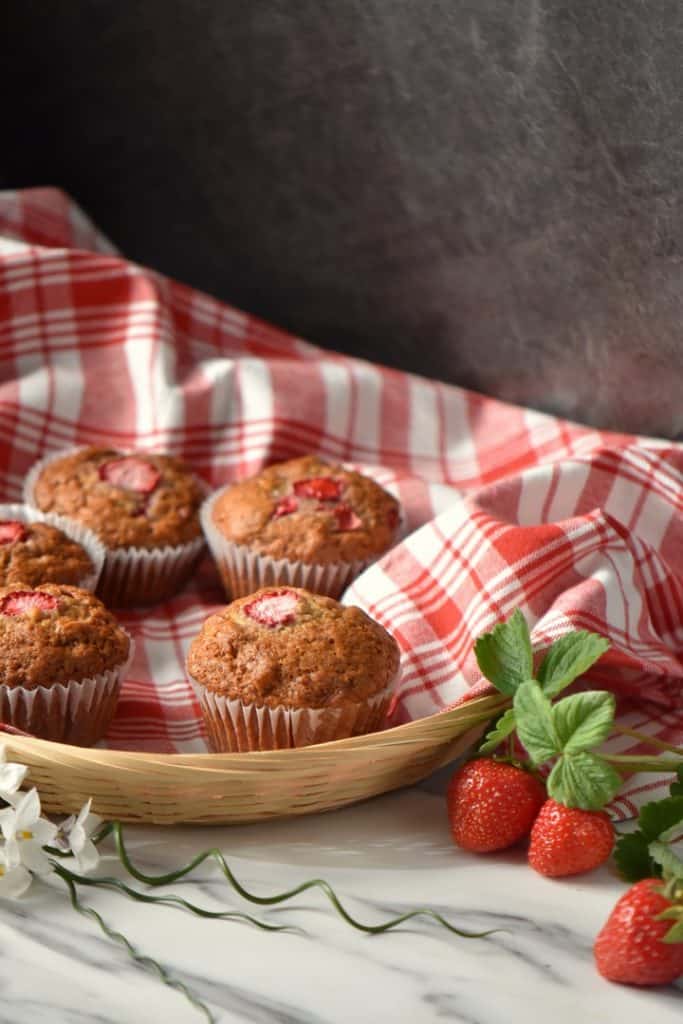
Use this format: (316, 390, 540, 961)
(5, 0, 683, 436)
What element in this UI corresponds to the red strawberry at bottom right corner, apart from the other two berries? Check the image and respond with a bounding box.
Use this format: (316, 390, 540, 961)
(594, 879, 683, 985)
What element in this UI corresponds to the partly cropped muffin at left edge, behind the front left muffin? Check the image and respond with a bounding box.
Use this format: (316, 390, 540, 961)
(0, 505, 104, 590)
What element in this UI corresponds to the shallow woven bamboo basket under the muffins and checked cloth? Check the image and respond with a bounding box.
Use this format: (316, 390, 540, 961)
(1, 694, 508, 825)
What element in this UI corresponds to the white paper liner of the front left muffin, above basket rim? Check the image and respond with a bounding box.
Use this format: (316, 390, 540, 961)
(0, 634, 135, 746)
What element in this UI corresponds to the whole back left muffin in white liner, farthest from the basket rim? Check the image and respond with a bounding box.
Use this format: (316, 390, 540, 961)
(25, 447, 205, 606)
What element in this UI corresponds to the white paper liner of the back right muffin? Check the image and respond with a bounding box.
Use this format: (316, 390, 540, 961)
(200, 484, 395, 600)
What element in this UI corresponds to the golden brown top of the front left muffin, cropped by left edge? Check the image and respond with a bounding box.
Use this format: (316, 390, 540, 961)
(0, 583, 130, 689)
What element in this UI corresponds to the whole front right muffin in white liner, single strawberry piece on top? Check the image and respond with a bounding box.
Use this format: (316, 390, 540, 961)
(187, 587, 399, 752)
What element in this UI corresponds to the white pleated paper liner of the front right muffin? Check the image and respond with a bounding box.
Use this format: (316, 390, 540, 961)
(189, 676, 398, 754)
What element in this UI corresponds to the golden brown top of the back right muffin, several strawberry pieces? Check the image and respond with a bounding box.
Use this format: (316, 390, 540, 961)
(212, 456, 399, 565)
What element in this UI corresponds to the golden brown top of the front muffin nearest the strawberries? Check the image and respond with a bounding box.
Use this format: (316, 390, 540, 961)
(187, 587, 399, 708)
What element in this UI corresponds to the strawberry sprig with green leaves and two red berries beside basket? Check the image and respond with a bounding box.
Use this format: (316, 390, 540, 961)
(449, 610, 683, 878)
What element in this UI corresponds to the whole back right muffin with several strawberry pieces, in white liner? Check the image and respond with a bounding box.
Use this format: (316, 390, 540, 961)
(202, 456, 400, 598)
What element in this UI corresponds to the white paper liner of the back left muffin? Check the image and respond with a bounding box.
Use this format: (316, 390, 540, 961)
(24, 445, 205, 607)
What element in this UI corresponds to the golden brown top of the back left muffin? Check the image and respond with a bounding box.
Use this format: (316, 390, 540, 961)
(33, 447, 204, 548)
